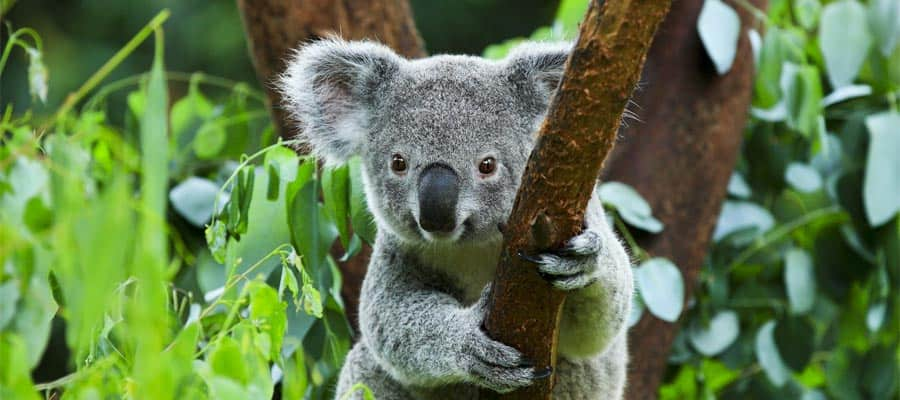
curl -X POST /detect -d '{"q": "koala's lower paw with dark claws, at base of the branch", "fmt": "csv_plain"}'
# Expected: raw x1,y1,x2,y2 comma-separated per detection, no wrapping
462,329,550,393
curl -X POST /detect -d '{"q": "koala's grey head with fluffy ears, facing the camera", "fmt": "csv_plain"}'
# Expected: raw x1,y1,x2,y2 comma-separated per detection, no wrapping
280,39,570,243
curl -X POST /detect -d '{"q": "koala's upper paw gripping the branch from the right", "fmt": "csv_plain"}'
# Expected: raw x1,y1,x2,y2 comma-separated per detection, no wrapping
519,230,603,290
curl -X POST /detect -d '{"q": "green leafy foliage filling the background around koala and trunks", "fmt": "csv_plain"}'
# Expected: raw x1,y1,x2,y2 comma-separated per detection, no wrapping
0,0,900,399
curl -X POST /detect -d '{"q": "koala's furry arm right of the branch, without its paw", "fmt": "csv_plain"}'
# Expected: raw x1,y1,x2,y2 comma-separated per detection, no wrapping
559,190,634,359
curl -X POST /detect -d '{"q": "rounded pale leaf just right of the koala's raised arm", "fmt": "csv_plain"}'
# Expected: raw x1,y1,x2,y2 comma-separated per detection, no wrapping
634,258,684,322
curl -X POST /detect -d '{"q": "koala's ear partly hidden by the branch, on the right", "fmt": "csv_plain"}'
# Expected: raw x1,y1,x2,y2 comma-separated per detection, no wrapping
506,42,572,105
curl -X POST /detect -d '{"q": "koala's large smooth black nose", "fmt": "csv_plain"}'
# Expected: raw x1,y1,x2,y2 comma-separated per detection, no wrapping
419,164,459,233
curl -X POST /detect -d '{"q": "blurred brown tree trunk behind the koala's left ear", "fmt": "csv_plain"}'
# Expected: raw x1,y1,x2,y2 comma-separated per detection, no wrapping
237,0,425,327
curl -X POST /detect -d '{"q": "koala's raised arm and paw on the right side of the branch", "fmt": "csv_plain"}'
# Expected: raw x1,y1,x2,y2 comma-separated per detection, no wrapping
526,199,634,359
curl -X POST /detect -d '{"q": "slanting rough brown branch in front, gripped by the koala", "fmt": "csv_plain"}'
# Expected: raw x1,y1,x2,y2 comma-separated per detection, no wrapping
480,0,671,400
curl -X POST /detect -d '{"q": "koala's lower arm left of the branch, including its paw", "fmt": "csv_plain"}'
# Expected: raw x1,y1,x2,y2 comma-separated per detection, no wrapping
360,245,534,392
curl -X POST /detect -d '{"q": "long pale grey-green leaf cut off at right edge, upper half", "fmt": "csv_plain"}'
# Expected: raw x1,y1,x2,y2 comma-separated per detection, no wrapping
863,112,900,226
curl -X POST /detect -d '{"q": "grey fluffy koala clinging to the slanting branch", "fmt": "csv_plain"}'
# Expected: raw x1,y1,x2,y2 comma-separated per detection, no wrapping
278,38,633,400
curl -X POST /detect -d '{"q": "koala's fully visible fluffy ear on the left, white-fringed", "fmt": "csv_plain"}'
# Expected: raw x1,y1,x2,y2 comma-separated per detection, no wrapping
278,38,404,163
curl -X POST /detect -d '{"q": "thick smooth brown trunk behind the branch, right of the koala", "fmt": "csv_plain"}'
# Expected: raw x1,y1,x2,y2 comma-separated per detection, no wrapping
604,0,766,400
